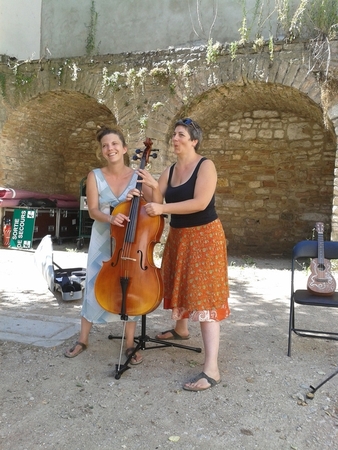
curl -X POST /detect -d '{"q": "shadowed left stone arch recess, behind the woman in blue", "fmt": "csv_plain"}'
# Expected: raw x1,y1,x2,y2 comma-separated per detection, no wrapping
0,90,116,195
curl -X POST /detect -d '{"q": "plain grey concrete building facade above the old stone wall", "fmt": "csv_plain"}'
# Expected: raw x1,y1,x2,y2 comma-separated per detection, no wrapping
0,0,277,60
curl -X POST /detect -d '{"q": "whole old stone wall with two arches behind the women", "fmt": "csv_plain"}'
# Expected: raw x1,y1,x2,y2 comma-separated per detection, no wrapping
0,43,338,254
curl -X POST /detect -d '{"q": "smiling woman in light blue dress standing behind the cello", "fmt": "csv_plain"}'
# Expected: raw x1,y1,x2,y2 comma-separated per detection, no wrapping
65,127,149,364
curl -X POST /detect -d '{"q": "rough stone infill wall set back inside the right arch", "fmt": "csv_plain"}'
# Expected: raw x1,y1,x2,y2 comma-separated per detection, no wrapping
205,110,335,254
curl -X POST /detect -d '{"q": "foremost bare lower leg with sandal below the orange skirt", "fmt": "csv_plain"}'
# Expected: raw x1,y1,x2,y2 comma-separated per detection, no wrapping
185,322,220,389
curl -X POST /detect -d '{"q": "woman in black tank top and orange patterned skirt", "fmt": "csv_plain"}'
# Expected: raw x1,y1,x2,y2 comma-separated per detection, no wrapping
135,118,230,391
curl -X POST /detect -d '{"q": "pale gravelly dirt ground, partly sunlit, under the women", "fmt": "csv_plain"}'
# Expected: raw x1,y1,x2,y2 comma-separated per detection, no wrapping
0,244,338,450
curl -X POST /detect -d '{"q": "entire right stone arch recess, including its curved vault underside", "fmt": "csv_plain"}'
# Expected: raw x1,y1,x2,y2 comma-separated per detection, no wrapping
168,83,336,254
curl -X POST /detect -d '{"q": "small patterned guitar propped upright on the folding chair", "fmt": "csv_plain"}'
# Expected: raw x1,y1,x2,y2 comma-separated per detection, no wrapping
307,222,336,295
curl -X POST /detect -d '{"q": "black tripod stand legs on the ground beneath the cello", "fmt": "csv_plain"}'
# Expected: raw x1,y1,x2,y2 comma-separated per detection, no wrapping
108,315,202,380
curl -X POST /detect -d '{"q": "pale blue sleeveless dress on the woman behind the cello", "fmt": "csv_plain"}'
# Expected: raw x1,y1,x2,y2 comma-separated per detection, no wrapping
81,169,139,324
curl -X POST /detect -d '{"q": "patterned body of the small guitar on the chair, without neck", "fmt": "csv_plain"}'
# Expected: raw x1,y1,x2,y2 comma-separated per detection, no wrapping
307,258,336,295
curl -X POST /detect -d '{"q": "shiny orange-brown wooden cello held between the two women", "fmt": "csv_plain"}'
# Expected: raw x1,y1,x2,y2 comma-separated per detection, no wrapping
95,138,164,320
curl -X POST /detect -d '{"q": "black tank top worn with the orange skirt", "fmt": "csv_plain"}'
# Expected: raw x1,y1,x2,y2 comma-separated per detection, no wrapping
165,158,218,228
